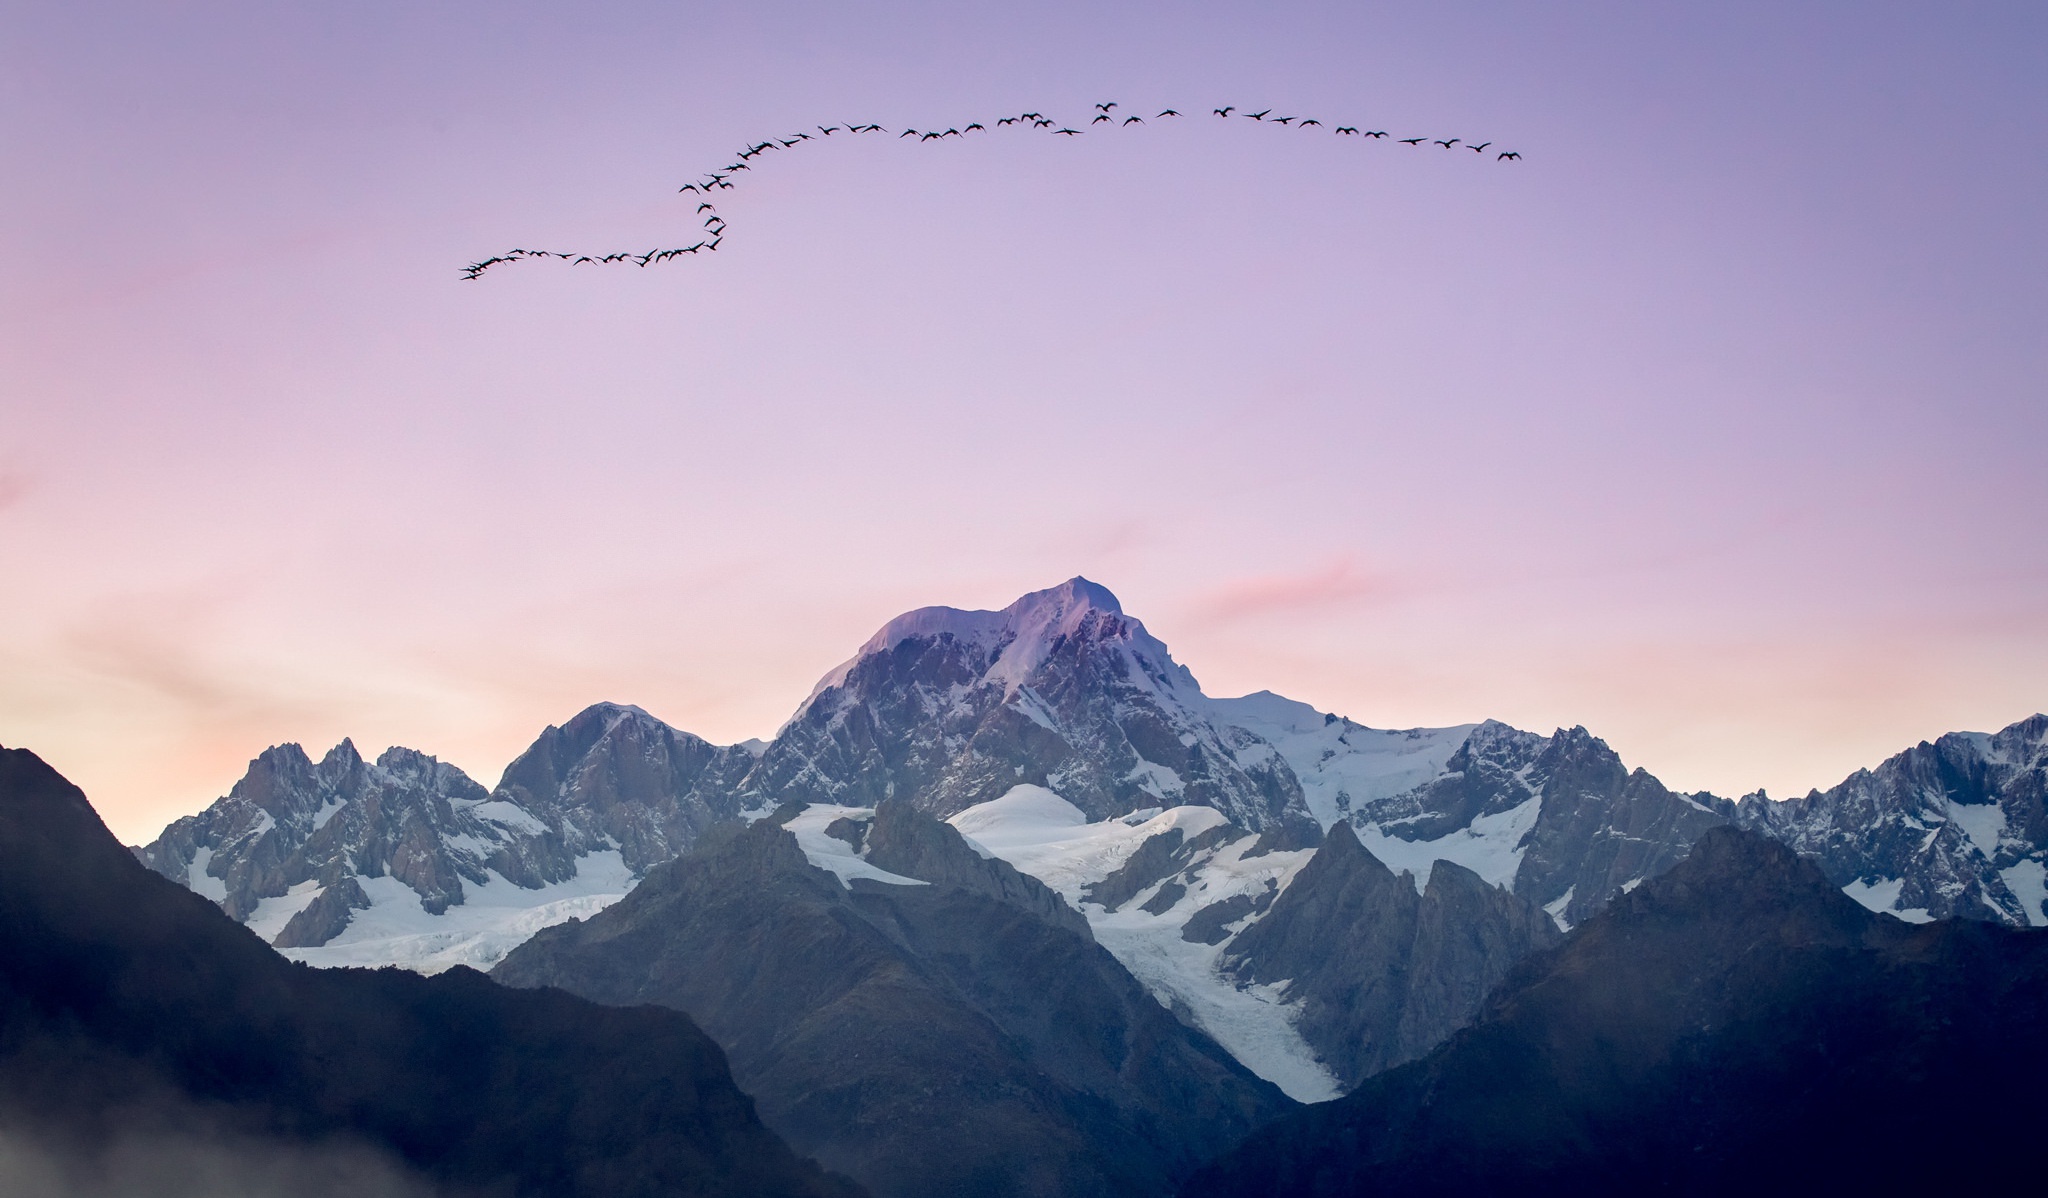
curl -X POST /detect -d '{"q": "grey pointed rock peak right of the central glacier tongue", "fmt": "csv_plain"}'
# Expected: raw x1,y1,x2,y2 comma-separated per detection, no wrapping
1190,823,1556,1087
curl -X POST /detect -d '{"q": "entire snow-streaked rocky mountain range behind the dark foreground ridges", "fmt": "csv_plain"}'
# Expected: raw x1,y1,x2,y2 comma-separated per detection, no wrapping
137,580,2048,1102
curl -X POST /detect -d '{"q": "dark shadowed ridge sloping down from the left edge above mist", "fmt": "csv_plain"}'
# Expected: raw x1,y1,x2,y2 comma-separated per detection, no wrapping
0,750,858,1198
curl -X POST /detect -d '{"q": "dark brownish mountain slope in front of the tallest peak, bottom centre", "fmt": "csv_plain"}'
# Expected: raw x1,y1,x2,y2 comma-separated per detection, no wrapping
494,803,1288,1198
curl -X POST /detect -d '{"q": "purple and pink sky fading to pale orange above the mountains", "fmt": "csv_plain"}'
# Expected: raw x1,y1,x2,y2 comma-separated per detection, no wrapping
0,0,2048,840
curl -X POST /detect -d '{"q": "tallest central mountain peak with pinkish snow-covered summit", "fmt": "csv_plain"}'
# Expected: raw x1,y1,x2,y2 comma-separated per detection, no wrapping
745,577,1315,842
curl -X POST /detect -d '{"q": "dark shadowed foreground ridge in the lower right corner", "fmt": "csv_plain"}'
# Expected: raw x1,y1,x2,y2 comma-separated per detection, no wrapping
1184,827,2048,1198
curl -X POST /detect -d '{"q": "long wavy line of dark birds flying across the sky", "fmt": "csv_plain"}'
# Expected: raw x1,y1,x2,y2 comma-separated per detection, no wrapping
463,100,1522,279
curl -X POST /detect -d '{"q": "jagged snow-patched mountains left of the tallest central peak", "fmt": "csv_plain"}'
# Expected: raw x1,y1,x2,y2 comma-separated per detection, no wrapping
137,702,754,971
